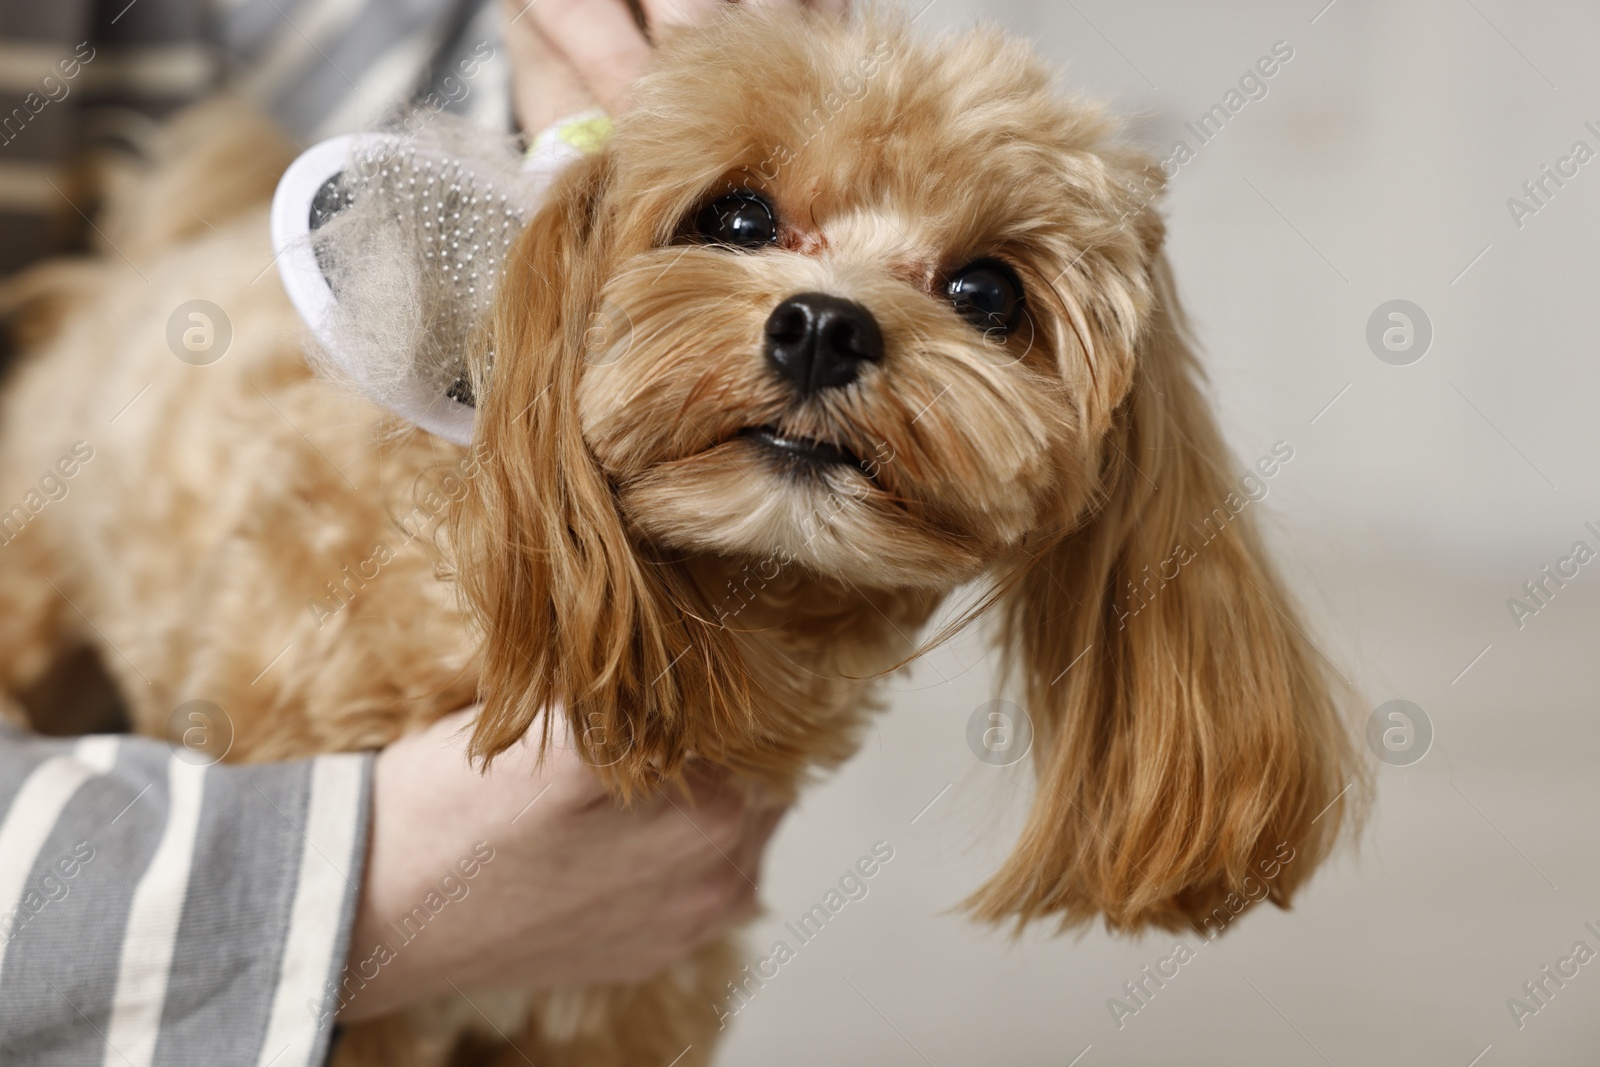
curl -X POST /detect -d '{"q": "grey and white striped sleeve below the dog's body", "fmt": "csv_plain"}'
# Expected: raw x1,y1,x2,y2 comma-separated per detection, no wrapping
0,725,371,1067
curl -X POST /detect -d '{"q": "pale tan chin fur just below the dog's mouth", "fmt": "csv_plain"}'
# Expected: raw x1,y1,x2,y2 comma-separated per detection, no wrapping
621,446,995,590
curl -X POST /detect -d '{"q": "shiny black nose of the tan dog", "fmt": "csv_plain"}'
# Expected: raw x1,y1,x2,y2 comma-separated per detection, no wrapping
766,293,883,397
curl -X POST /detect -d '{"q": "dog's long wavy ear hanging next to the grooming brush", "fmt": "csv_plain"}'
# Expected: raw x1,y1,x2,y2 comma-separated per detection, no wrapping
453,155,749,793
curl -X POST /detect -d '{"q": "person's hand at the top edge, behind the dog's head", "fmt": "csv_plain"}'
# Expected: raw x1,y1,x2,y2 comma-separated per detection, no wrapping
501,0,848,133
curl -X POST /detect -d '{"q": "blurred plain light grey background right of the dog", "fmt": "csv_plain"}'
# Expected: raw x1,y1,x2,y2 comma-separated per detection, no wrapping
722,0,1600,1067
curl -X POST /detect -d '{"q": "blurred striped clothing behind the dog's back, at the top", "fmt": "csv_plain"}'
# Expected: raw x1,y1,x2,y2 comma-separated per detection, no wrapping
0,0,510,275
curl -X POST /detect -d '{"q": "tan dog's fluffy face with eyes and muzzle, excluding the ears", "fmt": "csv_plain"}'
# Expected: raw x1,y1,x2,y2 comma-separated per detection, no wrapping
579,12,1152,587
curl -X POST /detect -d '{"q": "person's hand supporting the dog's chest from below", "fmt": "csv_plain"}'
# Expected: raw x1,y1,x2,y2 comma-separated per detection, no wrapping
339,710,782,1022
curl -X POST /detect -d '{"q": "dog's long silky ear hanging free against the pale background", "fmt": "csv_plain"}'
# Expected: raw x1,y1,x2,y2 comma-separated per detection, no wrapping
968,251,1362,931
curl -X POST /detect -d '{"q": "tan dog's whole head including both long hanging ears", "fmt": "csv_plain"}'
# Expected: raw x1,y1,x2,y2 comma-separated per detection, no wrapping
453,6,1355,929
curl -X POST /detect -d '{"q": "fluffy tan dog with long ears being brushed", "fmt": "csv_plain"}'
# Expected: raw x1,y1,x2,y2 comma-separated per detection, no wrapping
0,10,1357,1067
